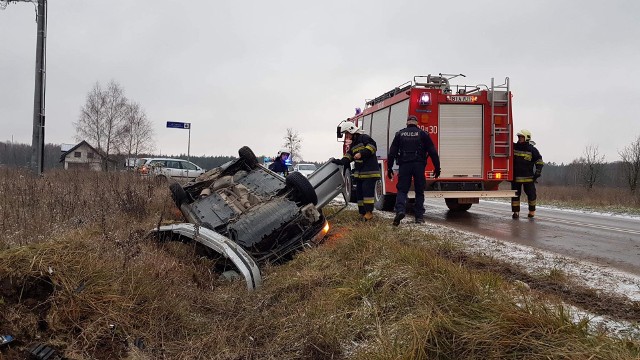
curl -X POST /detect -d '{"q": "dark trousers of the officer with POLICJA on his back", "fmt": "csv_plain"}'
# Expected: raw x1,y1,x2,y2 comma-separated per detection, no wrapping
395,162,427,219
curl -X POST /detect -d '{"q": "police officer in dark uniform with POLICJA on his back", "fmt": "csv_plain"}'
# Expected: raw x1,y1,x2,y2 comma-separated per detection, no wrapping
387,115,440,226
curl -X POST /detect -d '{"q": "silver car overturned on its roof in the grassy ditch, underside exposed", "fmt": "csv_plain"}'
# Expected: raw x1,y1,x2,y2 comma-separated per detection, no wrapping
152,146,346,289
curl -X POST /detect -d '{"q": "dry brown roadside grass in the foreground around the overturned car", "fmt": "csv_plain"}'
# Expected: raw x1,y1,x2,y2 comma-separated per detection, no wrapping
0,172,640,359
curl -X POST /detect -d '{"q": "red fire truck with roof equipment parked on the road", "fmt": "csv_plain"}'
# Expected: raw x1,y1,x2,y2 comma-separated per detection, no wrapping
338,74,515,211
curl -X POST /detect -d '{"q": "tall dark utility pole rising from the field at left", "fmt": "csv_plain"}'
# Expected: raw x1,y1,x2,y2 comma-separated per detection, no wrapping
0,0,47,175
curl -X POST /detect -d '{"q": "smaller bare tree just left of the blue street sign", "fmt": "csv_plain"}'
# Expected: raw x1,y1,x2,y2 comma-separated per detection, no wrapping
122,102,154,162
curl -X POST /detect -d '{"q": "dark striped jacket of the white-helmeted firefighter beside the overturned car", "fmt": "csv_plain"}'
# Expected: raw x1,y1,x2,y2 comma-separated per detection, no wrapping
342,134,381,179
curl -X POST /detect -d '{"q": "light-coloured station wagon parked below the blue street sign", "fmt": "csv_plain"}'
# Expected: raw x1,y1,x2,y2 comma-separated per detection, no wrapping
136,158,205,180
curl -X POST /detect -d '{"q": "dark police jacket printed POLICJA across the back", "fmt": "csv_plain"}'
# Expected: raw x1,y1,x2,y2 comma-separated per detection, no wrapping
387,125,440,169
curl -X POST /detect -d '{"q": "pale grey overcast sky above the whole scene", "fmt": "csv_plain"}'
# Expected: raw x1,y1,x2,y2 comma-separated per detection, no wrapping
0,0,640,163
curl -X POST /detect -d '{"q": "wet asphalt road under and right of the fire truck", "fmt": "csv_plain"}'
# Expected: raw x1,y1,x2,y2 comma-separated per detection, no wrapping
425,199,640,275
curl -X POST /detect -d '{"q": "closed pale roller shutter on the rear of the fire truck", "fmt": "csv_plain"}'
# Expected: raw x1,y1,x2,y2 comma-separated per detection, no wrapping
438,104,483,178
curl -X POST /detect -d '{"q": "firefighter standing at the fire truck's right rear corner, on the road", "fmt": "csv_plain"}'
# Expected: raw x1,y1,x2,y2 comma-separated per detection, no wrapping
511,129,544,219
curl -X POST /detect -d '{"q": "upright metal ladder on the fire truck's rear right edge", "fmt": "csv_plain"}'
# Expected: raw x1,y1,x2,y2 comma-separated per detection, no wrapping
489,77,512,171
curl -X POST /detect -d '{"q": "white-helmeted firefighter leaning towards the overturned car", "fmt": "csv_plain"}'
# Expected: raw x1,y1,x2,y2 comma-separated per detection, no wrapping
331,121,381,221
